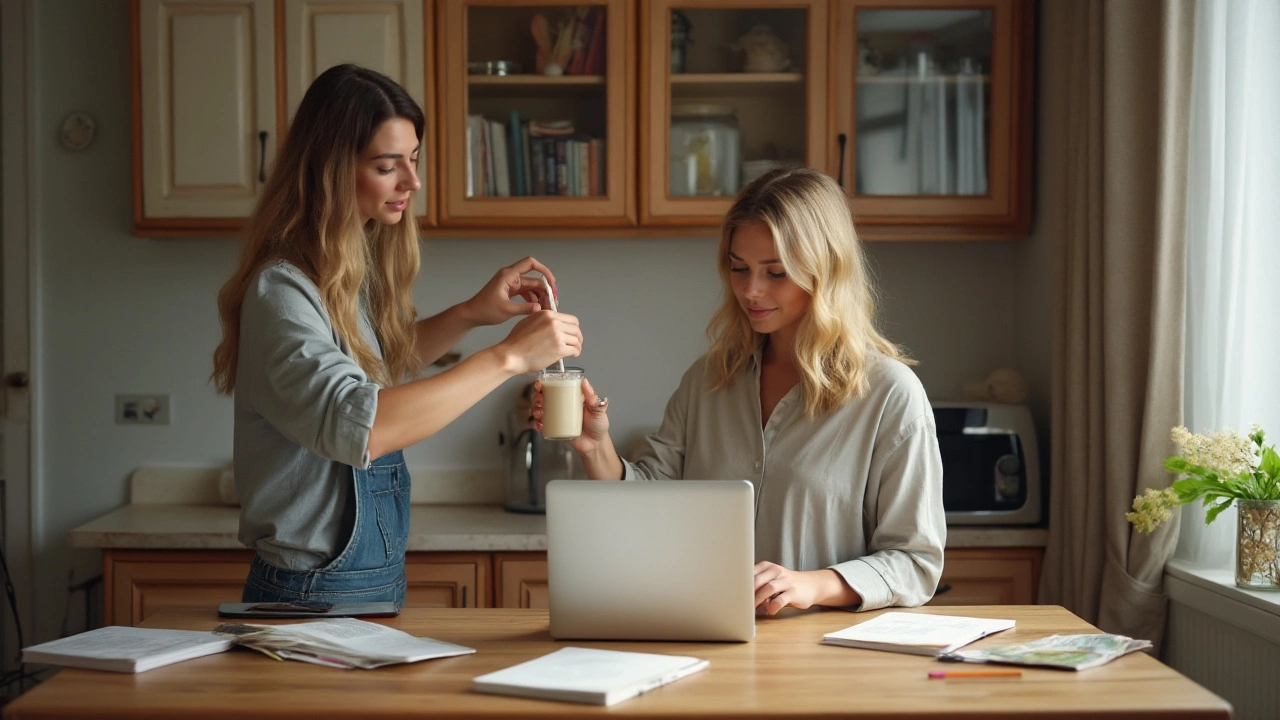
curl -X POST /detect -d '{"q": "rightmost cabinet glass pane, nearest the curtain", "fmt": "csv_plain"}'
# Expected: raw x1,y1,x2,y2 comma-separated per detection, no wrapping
854,10,992,196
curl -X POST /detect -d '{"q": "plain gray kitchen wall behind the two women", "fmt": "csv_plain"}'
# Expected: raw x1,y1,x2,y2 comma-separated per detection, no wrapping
24,0,1048,639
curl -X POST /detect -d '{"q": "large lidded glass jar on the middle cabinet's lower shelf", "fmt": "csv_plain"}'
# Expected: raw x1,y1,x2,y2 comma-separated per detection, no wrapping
669,102,742,197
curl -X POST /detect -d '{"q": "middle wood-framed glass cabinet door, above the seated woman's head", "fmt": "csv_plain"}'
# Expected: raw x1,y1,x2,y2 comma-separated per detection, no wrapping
639,0,829,227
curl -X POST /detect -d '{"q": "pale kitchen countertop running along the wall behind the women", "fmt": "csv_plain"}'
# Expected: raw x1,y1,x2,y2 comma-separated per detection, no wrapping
68,503,1048,552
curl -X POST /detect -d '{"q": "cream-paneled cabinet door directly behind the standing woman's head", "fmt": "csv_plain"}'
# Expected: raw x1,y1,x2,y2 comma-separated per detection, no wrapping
278,0,436,224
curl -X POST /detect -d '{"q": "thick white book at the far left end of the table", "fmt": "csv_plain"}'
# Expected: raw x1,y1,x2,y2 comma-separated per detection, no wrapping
22,625,232,673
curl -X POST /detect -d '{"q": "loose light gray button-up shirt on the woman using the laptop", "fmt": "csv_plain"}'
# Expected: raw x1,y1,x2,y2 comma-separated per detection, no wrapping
623,352,946,610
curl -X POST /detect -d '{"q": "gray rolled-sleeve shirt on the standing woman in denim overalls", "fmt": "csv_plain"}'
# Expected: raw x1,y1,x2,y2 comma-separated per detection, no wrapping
234,261,378,570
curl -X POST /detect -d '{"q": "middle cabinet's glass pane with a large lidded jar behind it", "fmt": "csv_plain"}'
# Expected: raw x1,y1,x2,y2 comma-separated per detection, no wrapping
667,8,808,197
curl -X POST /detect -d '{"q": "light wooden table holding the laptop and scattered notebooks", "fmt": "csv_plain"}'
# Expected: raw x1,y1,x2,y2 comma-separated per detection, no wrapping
5,606,1231,720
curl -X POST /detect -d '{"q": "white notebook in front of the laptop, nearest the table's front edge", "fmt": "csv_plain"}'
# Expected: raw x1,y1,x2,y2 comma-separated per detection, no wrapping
471,647,708,705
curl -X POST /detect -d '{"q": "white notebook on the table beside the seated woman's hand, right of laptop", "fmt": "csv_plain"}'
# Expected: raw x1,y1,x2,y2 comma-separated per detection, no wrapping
822,612,1014,656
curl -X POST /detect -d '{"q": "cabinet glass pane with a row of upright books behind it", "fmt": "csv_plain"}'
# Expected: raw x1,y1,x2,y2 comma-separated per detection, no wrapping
466,5,608,197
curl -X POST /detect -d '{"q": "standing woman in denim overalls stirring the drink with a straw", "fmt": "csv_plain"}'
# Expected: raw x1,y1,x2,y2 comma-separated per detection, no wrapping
212,65,582,603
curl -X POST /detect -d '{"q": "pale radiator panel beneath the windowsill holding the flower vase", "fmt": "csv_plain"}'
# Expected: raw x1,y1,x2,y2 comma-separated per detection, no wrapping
1161,566,1280,720
